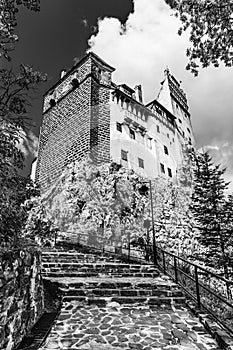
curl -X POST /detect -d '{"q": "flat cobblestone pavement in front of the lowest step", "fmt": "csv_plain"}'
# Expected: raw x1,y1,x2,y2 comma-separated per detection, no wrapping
41,300,219,350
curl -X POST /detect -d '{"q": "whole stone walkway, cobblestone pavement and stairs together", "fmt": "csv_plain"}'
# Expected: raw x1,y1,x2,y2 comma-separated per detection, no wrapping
41,251,222,350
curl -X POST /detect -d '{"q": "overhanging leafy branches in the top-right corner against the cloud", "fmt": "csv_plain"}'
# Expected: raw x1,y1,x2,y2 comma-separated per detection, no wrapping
165,0,233,76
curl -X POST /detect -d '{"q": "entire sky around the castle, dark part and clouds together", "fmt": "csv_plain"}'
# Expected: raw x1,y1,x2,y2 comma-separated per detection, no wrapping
12,0,233,191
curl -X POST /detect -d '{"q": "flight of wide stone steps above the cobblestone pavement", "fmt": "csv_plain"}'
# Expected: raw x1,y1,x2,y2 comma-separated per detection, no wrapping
42,251,185,305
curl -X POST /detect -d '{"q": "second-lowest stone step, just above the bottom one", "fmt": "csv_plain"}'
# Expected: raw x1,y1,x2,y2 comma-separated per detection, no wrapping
60,288,183,297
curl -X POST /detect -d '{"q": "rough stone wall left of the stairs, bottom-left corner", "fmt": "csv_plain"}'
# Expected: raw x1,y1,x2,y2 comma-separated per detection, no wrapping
0,247,44,350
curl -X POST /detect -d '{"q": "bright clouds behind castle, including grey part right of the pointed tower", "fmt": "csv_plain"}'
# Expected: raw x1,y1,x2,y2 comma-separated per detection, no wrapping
89,0,233,191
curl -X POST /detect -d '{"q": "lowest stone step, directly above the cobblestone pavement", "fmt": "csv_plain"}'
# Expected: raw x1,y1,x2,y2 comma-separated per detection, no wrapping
62,295,186,306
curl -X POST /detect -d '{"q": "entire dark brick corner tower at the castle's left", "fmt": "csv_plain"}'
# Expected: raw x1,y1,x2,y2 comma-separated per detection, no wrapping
36,53,114,190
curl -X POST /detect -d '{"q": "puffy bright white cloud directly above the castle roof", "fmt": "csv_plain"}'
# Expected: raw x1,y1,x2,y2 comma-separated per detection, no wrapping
89,0,188,101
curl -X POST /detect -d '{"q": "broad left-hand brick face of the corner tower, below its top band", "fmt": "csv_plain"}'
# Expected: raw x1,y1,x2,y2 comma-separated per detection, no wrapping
37,78,91,189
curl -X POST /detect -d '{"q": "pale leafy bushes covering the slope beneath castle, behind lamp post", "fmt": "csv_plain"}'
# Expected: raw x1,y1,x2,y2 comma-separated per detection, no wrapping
25,154,197,264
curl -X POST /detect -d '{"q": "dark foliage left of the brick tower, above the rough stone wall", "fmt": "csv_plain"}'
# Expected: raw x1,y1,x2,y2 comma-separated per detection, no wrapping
0,65,45,242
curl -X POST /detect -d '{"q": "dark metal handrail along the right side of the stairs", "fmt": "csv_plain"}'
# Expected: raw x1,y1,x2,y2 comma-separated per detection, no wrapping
53,231,233,335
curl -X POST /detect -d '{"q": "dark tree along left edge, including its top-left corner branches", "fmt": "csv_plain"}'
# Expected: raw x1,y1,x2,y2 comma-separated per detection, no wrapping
0,0,46,245
